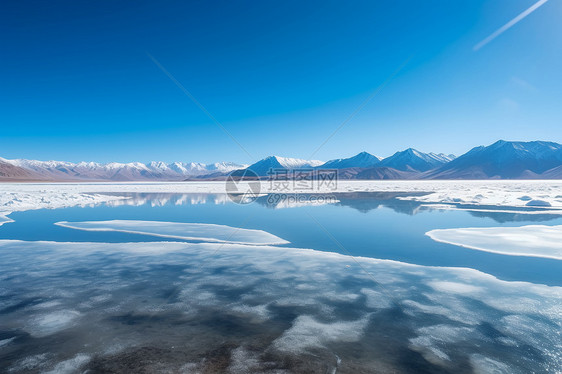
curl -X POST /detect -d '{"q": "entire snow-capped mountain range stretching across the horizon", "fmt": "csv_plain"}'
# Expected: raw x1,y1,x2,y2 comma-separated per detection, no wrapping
0,140,562,181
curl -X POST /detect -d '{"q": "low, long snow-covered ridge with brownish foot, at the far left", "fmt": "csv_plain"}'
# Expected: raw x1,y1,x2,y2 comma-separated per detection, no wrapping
1,159,247,181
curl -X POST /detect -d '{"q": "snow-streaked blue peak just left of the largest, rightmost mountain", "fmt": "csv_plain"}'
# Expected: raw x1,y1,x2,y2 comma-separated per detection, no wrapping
380,148,455,172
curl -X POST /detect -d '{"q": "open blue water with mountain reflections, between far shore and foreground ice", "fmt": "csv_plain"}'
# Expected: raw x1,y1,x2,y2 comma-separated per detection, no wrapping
0,192,562,286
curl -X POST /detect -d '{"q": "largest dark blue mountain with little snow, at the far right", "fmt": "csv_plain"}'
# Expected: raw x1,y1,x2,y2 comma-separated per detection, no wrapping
426,140,562,179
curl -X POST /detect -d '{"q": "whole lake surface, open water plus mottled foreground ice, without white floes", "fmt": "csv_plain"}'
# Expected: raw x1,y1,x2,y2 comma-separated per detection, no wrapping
0,193,562,373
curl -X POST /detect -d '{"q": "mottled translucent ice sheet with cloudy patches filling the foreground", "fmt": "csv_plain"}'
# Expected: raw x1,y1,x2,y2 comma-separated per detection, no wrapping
0,240,562,373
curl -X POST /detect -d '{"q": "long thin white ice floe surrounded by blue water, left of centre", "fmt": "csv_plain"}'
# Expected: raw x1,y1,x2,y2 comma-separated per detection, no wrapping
55,220,289,245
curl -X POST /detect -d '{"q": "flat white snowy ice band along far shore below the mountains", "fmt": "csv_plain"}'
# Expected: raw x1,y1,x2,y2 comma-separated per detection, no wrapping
0,180,562,213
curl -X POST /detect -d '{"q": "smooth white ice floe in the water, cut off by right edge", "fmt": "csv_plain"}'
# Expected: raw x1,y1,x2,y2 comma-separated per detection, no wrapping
426,225,562,260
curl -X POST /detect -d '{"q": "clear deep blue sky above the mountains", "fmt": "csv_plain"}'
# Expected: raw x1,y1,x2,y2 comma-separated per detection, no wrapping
0,0,562,163
